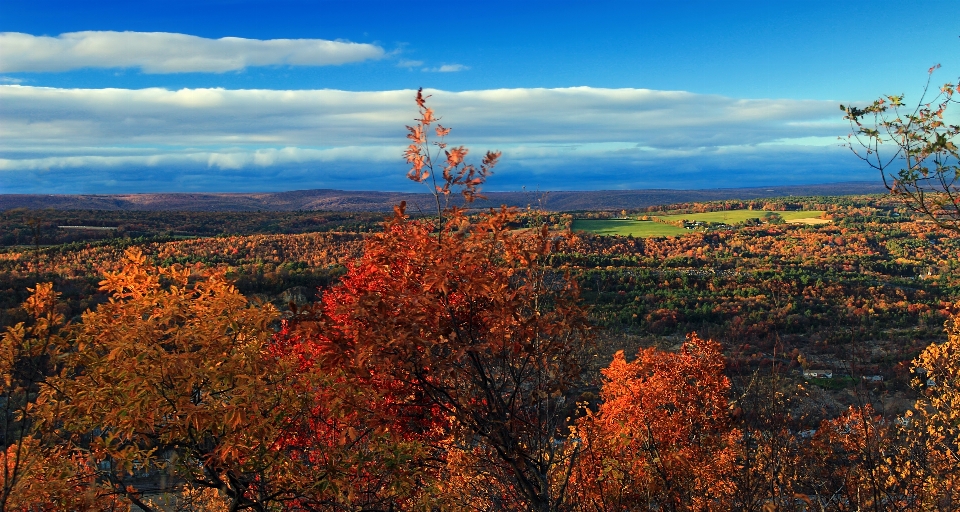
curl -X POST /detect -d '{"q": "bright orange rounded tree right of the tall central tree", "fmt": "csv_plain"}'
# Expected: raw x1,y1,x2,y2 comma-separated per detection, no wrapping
574,334,737,511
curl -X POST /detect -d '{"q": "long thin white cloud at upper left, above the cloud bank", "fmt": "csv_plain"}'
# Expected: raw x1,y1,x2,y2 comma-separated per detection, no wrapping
0,31,385,73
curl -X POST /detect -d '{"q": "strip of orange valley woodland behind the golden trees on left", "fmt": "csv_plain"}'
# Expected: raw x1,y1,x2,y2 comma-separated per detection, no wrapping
0,233,363,324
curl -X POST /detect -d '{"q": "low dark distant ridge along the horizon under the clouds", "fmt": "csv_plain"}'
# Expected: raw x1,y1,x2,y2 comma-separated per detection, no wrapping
0,181,886,213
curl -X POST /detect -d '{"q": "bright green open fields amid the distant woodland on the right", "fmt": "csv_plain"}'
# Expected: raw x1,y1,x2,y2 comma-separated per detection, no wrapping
573,210,823,238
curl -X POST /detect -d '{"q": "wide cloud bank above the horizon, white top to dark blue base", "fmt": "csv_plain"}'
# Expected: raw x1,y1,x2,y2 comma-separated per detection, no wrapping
0,85,874,193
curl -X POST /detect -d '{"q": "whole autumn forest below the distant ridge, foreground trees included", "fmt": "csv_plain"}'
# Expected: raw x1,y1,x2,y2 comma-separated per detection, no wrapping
0,84,960,512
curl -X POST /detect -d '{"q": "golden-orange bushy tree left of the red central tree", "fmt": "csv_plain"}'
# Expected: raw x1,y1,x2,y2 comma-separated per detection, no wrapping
28,249,314,510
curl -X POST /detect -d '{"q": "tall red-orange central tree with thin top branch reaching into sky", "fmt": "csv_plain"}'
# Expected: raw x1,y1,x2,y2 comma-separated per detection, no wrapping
282,92,588,510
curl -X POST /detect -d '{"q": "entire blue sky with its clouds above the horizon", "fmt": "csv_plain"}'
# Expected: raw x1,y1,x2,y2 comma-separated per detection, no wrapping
0,0,960,193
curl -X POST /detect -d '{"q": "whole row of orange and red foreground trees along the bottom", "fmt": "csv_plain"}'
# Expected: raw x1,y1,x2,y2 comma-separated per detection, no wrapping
0,233,960,511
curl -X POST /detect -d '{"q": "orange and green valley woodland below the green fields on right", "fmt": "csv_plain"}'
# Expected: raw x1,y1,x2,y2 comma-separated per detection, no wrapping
568,218,960,340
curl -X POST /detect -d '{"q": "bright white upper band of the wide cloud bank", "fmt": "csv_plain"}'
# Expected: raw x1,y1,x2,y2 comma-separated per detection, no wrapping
0,85,848,151
